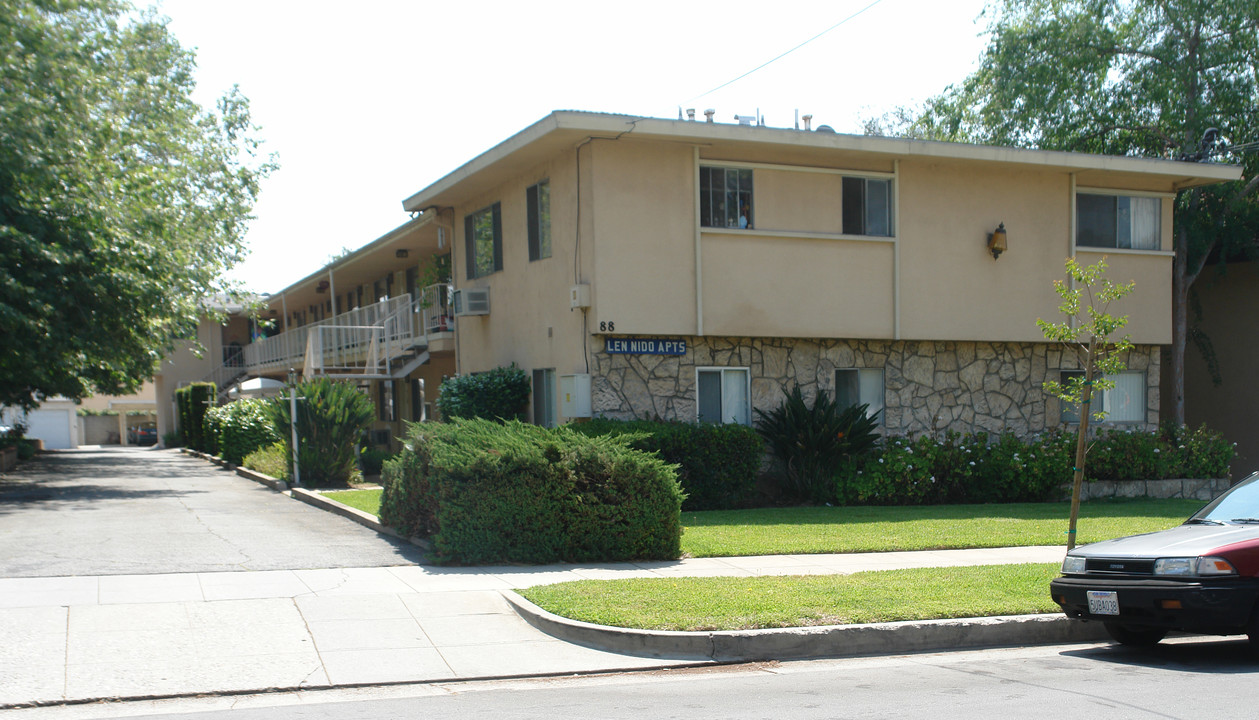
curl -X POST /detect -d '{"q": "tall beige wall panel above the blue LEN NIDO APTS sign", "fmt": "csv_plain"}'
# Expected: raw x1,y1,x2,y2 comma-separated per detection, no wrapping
589,141,695,335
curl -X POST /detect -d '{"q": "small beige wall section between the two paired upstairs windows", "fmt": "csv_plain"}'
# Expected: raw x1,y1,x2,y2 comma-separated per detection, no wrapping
752,170,844,234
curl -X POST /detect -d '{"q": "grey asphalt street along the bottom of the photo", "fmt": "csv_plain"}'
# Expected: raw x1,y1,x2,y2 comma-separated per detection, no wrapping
6,638,1259,720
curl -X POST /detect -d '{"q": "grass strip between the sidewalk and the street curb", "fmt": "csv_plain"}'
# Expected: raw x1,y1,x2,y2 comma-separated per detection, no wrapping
517,563,1058,631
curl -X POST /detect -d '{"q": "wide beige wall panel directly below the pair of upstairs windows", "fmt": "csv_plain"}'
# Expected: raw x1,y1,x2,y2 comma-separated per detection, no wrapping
704,234,893,339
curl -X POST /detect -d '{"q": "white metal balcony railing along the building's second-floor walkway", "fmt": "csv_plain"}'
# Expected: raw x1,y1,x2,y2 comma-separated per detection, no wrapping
244,284,454,375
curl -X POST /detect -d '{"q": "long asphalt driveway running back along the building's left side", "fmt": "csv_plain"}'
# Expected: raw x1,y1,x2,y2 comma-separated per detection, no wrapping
0,447,422,578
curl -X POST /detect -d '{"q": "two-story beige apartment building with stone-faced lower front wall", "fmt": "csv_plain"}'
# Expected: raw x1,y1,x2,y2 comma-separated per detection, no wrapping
154,111,1240,450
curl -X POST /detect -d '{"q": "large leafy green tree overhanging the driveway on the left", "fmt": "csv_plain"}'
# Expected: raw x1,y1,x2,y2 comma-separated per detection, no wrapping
0,0,273,407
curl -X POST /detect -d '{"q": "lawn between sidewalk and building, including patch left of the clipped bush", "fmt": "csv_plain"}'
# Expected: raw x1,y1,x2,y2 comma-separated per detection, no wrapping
317,490,1202,558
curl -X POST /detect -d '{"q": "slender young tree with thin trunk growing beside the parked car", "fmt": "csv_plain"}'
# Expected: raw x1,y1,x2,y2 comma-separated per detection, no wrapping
1036,258,1136,550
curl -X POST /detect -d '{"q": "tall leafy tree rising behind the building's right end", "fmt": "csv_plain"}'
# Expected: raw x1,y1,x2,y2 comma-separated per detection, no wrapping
867,0,1259,423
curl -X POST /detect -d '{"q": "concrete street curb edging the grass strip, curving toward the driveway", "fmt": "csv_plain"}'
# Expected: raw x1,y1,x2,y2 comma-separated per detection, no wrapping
501,590,1107,662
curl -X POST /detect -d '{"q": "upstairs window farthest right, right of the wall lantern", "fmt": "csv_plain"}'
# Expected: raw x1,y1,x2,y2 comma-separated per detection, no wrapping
1075,193,1162,250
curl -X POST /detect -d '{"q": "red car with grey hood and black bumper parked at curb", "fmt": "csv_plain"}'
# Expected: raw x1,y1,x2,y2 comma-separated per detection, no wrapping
1050,473,1259,652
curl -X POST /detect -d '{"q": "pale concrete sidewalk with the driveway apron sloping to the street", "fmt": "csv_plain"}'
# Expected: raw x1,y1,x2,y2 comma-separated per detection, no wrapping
0,546,1079,709
